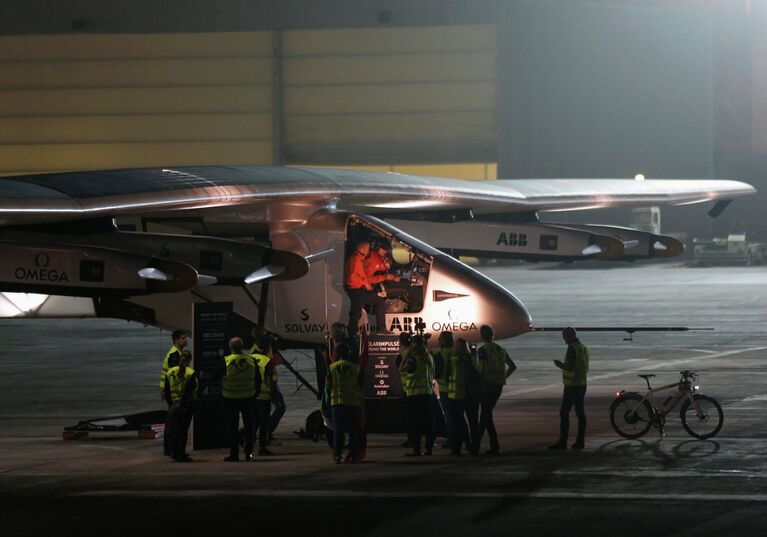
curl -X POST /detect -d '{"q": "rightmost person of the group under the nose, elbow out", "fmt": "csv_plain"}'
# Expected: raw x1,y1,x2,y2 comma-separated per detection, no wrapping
477,324,517,455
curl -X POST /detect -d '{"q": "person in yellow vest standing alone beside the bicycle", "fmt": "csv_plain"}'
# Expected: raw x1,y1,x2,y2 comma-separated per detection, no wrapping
549,327,589,449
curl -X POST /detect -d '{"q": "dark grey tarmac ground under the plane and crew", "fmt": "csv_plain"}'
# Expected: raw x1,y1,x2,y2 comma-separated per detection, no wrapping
0,263,767,536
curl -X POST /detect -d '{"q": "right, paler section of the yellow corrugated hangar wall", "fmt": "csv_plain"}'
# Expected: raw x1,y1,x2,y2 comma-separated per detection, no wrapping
283,26,496,163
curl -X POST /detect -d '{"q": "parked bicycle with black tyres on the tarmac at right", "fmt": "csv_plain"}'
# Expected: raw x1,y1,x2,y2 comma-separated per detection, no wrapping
610,370,724,440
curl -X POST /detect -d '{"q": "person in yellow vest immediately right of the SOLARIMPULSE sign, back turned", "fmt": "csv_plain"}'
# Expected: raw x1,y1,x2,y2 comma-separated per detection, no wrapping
405,335,434,456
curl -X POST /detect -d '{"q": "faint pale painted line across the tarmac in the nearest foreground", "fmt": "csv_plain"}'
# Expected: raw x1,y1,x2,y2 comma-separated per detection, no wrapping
70,489,767,503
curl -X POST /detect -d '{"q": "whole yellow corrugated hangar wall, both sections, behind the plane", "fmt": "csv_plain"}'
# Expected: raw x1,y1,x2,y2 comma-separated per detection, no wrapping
0,26,496,174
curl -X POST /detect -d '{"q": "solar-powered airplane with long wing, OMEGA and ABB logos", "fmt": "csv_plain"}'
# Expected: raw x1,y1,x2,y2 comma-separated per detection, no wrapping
0,167,755,347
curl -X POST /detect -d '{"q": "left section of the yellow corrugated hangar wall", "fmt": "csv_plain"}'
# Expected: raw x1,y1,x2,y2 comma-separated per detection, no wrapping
0,32,272,173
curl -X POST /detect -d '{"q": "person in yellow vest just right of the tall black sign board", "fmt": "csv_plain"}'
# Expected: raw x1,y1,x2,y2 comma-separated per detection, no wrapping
221,337,262,462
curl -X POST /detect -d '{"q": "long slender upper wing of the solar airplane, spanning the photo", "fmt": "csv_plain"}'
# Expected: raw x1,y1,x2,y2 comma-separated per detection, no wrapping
0,166,755,226
